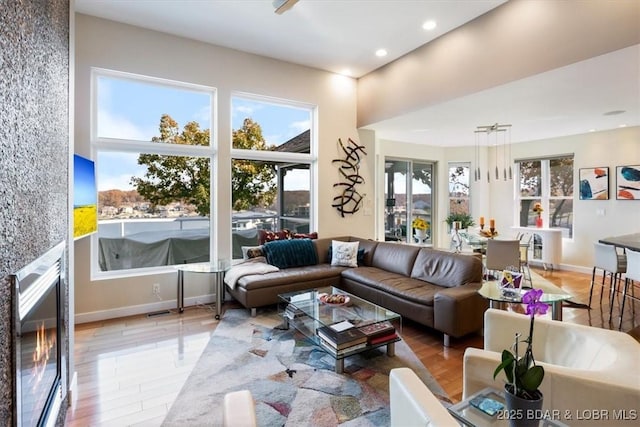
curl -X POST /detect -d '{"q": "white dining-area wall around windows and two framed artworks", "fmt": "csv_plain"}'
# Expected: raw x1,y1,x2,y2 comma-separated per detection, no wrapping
376,127,640,272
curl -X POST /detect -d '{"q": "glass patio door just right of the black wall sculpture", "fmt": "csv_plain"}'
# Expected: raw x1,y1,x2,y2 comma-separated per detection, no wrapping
385,158,434,244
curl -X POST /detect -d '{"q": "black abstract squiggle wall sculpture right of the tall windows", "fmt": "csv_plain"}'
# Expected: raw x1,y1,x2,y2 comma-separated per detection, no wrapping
331,138,367,218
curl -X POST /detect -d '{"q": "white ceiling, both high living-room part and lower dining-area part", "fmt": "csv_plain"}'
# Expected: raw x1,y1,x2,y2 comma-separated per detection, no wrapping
75,0,640,146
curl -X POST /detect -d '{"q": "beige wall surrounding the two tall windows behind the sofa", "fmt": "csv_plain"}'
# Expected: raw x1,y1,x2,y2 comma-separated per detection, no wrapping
75,14,374,321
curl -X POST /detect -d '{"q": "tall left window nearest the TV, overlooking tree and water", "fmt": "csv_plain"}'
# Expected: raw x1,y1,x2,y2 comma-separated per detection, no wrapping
91,69,215,276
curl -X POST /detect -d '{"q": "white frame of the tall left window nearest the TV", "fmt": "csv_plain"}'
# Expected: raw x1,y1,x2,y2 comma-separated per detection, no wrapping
89,67,219,281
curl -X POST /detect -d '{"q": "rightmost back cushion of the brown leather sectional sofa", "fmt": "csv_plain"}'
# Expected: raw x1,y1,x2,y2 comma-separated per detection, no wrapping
411,248,482,288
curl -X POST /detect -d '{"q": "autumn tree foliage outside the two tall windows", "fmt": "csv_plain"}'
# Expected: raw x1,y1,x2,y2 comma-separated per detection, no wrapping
131,114,276,216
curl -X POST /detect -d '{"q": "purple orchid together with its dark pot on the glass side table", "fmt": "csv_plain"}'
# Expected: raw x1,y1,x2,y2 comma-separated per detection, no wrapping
493,289,549,426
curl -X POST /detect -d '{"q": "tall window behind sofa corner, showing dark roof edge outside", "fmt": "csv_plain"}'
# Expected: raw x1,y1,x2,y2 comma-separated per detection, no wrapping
231,95,316,258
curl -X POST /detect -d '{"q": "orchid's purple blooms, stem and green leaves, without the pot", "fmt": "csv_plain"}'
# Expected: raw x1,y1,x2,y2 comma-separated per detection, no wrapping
493,289,549,400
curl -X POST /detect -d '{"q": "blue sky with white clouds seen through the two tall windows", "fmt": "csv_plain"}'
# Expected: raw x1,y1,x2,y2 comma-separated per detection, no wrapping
96,76,311,191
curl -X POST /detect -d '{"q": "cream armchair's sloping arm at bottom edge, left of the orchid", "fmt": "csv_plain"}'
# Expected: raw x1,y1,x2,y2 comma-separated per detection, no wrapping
389,368,458,427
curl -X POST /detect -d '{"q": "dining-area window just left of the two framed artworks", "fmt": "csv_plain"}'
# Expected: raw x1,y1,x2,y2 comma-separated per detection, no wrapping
517,156,573,237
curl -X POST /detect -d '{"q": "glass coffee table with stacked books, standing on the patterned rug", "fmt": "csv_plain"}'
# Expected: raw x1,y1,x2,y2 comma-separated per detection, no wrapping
278,286,402,374
